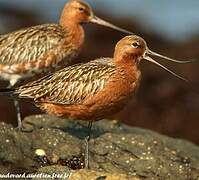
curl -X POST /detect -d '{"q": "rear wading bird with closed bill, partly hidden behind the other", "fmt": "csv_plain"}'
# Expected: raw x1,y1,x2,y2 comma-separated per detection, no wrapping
0,0,132,129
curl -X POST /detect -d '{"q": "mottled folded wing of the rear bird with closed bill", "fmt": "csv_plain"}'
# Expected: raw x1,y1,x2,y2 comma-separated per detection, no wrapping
0,24,68,65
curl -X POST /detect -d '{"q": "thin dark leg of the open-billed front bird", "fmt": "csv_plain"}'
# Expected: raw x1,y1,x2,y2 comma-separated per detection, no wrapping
84,121,93,169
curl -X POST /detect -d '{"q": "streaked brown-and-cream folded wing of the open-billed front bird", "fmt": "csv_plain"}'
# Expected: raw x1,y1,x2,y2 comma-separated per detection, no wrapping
16,58,115,104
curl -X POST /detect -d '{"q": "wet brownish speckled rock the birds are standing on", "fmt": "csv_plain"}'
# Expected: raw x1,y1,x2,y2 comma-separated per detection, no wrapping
0,115,199,180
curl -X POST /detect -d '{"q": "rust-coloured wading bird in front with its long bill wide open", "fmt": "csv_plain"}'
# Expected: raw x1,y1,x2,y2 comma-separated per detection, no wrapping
1,35,194,167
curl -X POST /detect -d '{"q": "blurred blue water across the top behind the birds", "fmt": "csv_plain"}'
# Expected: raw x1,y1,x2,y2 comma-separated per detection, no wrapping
0,0,199,42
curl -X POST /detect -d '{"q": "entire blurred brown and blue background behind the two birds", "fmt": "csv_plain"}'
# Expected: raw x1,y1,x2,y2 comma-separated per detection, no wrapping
0,0,199,143
